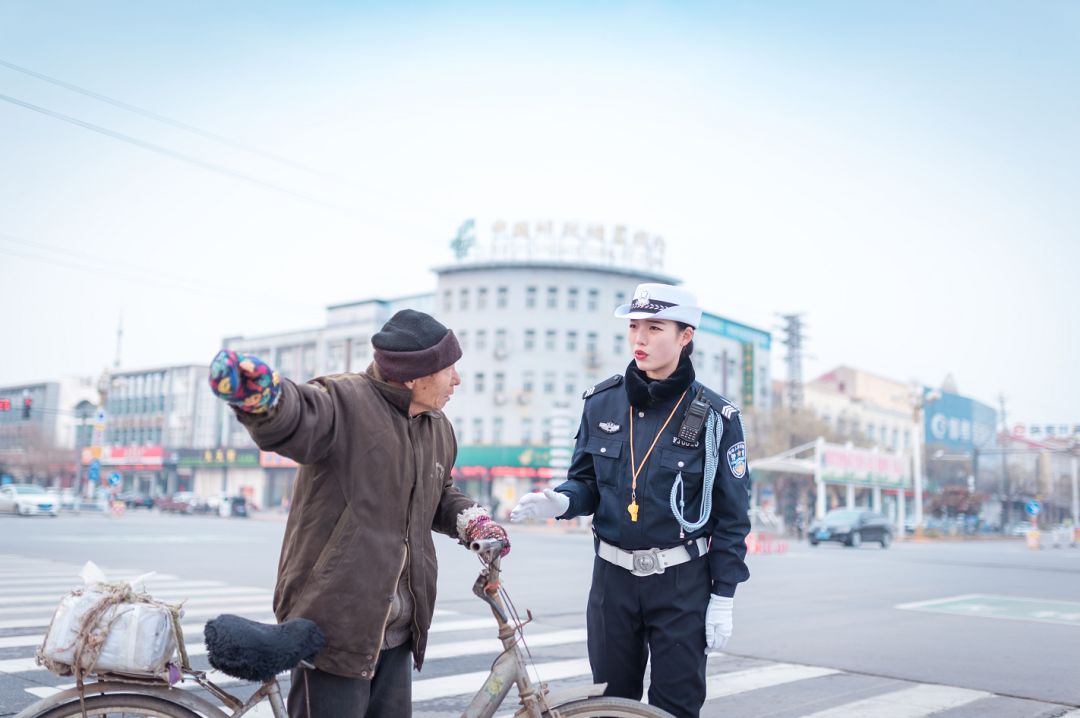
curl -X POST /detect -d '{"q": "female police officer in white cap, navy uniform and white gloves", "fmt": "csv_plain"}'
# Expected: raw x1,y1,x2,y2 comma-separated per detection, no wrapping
511,284,750,716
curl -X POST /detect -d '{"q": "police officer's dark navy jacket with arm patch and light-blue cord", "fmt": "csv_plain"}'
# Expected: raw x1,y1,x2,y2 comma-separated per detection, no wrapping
555,369,750,596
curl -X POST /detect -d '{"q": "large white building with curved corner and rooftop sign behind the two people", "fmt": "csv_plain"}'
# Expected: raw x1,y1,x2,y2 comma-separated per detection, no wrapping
220,221,771,510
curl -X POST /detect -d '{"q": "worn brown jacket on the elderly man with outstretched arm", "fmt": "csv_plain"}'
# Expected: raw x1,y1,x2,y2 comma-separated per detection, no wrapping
237,364,475,678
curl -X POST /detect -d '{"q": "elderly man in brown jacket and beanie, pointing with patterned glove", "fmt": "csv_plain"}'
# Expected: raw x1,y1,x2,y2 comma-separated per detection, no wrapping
210,309,510,718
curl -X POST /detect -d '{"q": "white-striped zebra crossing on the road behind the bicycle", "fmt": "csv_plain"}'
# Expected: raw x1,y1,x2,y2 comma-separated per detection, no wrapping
0,555,1080,718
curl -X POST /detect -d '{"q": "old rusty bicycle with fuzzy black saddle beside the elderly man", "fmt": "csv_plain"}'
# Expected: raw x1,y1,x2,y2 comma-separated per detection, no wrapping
15,540,672,718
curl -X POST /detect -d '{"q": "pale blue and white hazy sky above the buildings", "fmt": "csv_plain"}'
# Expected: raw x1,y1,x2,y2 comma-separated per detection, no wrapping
0,0,1080,423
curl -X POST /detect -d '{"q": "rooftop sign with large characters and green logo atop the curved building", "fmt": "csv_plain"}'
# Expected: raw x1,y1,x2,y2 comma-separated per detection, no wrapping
450,219,665,271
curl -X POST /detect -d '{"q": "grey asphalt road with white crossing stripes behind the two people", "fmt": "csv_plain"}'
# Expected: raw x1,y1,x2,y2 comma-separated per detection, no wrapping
0,512,1080,718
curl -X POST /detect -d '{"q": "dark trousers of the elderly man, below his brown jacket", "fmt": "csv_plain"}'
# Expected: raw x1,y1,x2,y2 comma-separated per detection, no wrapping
287,641,413,718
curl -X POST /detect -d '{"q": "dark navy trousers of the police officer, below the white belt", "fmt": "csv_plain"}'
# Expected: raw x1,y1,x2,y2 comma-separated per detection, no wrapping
586,556,711,718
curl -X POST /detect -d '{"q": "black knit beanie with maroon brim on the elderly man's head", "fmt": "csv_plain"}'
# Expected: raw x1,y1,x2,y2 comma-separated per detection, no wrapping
372,309,461,383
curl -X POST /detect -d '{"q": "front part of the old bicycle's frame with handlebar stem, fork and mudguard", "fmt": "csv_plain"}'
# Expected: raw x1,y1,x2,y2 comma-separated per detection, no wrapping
461,544,605,718
